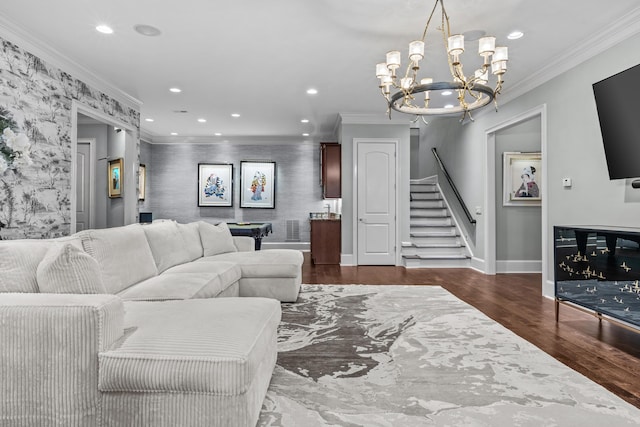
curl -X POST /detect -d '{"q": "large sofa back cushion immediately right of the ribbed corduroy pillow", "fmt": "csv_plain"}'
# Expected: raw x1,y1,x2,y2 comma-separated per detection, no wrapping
77,224,158,294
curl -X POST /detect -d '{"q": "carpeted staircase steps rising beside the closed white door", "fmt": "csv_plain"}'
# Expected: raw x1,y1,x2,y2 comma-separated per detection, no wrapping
402,178,470,268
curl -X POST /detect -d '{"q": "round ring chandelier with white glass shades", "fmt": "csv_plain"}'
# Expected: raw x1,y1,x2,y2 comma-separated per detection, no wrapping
376,0,509,123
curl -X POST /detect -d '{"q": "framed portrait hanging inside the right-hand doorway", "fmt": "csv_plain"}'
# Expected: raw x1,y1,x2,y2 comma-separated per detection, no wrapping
502,152,543,206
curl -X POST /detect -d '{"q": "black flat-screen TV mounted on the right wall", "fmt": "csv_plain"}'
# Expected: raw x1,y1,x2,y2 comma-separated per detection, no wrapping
593,65,640,181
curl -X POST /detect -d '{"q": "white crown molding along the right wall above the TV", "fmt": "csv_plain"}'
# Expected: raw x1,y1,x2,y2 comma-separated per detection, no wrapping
500,7,640,105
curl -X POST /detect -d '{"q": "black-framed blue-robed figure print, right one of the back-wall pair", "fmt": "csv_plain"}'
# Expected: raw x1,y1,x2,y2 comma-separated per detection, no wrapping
240,160,276,209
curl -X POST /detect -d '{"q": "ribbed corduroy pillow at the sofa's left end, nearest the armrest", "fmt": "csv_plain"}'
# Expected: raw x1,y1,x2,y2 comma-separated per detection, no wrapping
36,243,107,294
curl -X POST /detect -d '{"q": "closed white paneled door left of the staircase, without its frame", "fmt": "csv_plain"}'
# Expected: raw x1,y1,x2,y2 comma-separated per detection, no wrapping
357,142,396,265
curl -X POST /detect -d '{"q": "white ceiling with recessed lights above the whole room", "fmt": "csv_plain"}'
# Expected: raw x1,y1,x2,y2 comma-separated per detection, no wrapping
0,0,640,141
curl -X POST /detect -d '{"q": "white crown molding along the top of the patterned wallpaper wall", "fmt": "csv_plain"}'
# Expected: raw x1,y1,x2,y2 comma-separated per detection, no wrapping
0,15,142,111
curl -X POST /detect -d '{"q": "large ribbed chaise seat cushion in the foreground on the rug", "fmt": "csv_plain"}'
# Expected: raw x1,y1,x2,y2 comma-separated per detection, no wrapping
99,298,281,396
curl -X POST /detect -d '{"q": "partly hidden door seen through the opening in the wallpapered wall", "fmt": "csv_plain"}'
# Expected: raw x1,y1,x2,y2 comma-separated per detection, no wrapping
76,139,95,232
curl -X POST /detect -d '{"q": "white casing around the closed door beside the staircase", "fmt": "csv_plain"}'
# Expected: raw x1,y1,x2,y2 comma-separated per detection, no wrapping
351,138,402,265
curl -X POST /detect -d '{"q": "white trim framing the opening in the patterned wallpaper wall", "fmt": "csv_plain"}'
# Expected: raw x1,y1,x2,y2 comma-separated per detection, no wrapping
70,99,139,234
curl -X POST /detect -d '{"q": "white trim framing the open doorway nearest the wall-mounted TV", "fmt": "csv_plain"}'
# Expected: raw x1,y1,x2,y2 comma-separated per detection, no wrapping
484,104,549,293
